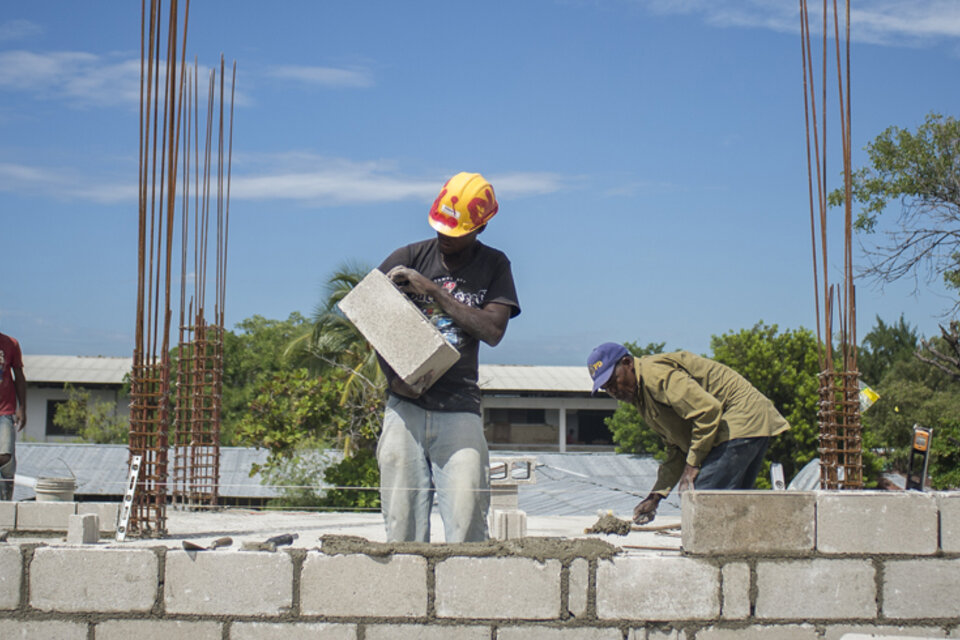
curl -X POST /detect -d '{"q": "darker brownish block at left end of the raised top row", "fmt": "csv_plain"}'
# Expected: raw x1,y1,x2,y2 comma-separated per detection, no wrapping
680,491,816,555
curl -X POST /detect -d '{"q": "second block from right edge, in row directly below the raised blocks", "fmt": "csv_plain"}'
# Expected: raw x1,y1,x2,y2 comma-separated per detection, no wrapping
754,559,877,620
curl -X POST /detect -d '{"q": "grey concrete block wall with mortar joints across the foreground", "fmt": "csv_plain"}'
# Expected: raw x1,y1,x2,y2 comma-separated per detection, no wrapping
0,492,960,640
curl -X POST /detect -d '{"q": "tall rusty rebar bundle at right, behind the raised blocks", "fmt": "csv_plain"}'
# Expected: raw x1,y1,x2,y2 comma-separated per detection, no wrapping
800,0,863,489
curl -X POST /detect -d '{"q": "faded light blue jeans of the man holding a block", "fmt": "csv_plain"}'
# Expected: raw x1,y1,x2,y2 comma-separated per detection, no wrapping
377,396,490,542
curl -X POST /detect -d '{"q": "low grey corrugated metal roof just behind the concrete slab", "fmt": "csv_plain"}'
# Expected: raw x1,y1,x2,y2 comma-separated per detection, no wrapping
7,442,680,517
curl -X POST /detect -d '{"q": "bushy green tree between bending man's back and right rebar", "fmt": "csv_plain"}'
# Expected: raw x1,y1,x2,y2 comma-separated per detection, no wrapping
710,321,820,487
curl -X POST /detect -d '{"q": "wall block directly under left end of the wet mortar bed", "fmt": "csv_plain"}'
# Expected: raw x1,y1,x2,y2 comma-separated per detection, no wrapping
300,552,427,617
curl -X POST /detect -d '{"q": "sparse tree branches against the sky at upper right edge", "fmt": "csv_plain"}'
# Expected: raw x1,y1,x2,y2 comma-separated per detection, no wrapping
829,113,960,298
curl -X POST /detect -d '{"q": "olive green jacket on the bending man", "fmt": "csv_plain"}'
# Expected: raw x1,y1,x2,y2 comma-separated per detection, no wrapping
633,351,790,496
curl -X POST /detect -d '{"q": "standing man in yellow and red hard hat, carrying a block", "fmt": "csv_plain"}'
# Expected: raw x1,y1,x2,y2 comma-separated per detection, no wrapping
377,173,520,542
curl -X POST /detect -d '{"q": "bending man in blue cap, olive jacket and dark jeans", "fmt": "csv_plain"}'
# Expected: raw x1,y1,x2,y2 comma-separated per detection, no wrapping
587,342,790,524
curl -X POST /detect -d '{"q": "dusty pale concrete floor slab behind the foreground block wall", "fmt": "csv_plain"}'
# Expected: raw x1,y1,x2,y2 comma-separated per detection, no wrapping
10,508,680,557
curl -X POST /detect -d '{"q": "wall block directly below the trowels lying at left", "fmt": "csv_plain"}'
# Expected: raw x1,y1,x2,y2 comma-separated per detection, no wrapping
164,551,293,616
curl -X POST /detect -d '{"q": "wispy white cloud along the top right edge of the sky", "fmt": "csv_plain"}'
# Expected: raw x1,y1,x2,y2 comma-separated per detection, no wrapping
637,0,960,46
